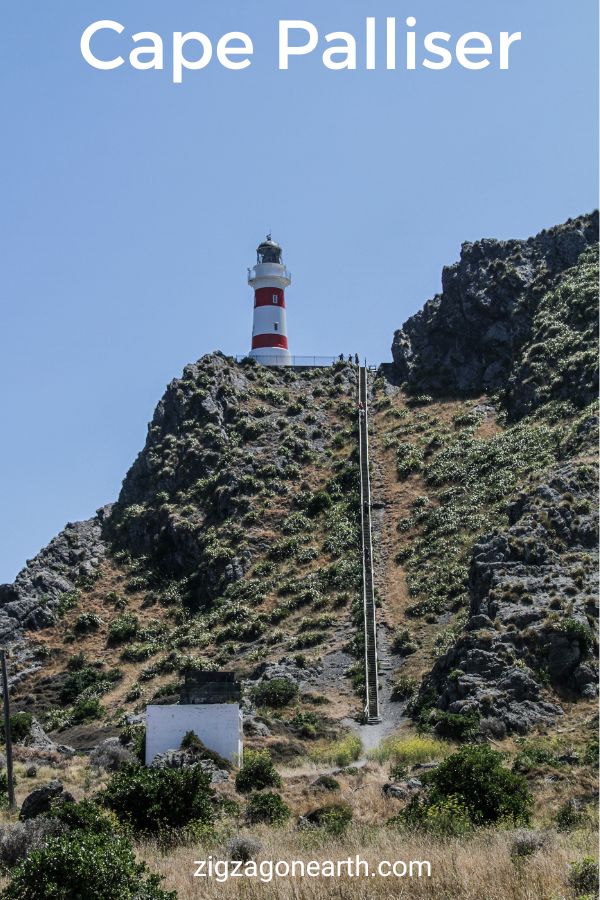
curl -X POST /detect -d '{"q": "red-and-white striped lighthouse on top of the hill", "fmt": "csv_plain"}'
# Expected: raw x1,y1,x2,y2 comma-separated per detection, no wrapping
248,234,292,366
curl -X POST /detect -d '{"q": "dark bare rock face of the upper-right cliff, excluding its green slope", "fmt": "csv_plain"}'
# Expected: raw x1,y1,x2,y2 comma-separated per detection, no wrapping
392,212,598,409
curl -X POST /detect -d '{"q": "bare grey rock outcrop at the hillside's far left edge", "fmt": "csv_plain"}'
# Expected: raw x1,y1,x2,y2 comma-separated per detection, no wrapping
0,507,110,644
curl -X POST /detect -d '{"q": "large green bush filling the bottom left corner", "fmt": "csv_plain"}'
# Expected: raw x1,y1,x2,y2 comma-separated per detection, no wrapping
3,832,176,900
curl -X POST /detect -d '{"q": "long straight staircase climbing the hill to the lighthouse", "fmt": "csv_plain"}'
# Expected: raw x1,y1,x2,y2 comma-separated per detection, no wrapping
358,366,381,725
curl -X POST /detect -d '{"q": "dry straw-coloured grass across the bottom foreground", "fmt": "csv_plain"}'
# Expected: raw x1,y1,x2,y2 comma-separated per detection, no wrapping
139,826,595,900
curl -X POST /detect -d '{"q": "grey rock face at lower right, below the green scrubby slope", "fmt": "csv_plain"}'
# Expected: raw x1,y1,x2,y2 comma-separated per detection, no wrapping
421,464,598,737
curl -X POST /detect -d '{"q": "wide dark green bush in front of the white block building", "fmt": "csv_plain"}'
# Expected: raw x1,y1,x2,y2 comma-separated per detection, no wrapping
101,766,214,833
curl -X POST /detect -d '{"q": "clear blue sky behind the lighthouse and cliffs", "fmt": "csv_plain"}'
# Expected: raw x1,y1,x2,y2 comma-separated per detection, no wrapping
0,0,598,581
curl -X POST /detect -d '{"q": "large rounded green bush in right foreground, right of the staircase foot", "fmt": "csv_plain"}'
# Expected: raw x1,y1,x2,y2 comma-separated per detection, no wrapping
427,745,532,825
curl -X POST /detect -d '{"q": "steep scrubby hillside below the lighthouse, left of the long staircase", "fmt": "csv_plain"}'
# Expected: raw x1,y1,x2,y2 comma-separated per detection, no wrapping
4,354,370,747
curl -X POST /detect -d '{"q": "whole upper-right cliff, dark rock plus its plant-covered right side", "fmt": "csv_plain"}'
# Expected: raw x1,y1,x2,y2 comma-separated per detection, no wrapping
392,212,598,415
